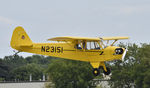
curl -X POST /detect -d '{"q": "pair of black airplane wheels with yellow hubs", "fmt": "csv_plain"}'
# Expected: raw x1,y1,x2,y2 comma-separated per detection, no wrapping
93,67,111,76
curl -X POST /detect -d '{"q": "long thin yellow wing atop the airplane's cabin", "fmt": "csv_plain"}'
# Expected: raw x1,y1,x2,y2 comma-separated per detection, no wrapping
48,36,129,41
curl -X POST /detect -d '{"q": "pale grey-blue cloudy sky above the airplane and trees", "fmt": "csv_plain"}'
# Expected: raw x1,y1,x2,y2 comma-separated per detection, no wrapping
0,0,150,58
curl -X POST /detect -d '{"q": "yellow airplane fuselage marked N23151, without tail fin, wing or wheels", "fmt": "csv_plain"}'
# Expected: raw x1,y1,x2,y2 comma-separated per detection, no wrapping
19,43,122,62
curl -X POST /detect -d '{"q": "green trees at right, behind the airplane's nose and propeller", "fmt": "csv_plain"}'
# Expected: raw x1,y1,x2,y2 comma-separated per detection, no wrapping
110,44,150,88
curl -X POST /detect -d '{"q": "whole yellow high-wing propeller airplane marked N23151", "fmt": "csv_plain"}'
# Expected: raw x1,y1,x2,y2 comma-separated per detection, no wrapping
11,26,129,76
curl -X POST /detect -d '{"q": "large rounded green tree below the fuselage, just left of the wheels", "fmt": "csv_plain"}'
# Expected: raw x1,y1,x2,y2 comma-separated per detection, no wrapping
47,59,93,88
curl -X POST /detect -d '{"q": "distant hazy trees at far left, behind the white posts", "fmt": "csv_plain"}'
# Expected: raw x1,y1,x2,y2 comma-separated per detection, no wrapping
0,55,54,81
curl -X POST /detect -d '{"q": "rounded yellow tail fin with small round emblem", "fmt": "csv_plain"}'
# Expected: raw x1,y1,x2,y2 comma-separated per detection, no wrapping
10,26,33,51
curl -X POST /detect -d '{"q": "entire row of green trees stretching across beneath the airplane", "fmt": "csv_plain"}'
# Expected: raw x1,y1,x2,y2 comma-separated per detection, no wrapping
0,43,150,88
